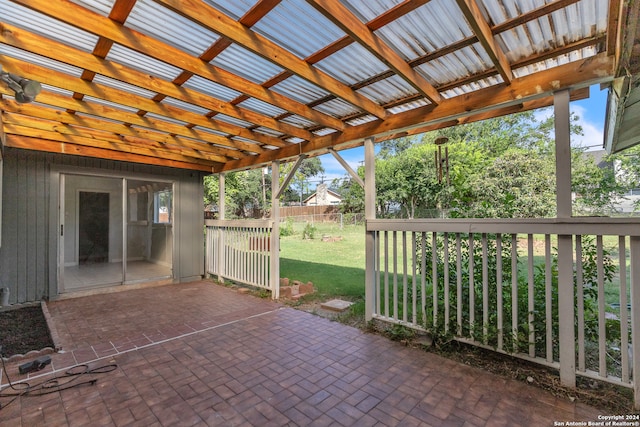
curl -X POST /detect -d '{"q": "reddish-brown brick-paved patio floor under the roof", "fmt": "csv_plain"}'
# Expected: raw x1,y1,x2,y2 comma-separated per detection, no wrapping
0,281,605,426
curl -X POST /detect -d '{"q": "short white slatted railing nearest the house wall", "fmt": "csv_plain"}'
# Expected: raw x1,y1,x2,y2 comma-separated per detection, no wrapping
205,220,277,290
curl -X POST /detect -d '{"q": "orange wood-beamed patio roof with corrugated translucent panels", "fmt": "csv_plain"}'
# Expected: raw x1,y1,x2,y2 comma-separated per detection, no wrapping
0,0,638,173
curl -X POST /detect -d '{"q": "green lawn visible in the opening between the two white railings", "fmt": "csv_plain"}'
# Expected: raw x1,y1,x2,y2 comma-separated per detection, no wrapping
280,223,365,299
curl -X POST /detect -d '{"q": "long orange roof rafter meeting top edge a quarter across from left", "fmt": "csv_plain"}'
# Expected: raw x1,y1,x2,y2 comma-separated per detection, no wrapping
156,0,387,118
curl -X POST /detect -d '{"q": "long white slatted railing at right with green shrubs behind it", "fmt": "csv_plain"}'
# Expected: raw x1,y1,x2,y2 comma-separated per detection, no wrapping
367,218,640,406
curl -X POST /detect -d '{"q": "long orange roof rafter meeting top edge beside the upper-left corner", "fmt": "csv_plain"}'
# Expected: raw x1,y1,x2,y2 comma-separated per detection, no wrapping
10,0,346,130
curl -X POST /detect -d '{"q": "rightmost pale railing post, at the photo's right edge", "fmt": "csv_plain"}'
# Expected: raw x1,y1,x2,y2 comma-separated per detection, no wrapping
620,236,640,409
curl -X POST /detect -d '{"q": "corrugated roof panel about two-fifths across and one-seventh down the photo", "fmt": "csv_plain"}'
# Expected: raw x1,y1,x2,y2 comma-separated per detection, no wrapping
211,44,283,83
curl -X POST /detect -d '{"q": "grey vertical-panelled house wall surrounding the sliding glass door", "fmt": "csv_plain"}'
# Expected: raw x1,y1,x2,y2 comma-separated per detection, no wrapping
0,148,204,304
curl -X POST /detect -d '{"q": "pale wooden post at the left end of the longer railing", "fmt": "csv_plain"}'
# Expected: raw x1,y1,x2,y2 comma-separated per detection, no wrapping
364,138,376,322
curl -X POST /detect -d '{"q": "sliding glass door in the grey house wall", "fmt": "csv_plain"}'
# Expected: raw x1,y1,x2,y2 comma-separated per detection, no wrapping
59,174,173,292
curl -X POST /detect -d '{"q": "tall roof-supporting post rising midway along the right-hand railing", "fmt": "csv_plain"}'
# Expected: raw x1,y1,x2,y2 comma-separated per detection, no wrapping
553,90,576,387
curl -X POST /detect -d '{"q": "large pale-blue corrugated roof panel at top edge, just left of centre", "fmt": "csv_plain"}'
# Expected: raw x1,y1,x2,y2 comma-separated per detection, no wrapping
252,0,345,58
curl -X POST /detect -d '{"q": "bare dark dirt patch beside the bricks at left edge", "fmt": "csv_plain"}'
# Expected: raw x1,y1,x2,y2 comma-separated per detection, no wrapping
0,305,54,358
